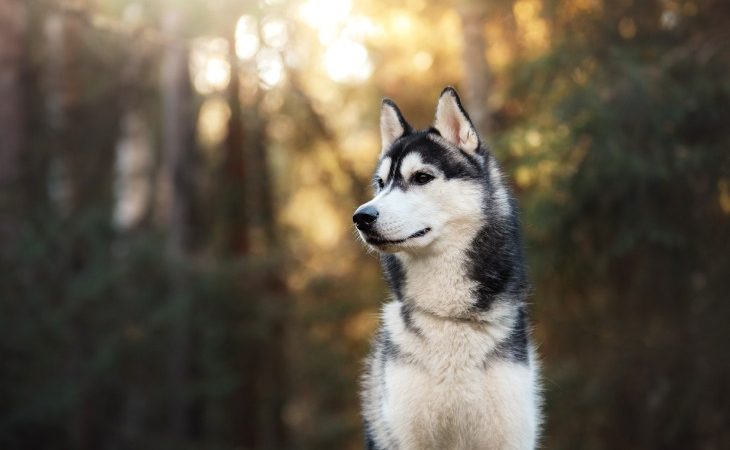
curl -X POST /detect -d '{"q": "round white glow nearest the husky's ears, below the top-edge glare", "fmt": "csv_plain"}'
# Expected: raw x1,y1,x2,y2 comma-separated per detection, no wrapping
324,39,373,83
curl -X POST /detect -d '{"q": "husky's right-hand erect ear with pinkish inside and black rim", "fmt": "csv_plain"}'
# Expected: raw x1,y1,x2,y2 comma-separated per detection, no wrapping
433,86,479,153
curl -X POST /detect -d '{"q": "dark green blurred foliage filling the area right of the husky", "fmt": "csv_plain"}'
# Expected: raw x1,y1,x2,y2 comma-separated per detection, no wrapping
502,2,730,448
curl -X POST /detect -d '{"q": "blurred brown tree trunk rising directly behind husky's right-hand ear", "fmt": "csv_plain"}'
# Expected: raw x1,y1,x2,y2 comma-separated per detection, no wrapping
459,1,492,138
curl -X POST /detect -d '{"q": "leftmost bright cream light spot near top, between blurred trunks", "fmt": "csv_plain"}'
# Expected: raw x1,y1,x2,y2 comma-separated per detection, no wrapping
190,38,231,94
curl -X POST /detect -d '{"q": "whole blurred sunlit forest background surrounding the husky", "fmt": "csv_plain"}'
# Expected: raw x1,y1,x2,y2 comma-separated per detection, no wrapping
0,0,730,450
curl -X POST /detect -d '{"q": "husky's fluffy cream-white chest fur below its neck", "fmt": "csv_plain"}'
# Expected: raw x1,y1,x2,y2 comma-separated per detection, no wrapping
366,302,539,450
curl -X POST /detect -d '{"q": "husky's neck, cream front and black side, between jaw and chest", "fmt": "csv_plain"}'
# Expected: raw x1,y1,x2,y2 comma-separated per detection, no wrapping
384,212,527,322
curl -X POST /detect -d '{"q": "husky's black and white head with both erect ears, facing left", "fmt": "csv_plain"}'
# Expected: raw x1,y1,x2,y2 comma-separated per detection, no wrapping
353,87,507,253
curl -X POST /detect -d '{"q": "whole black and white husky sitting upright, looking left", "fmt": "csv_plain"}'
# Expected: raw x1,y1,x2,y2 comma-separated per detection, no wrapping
353,87,541,450
